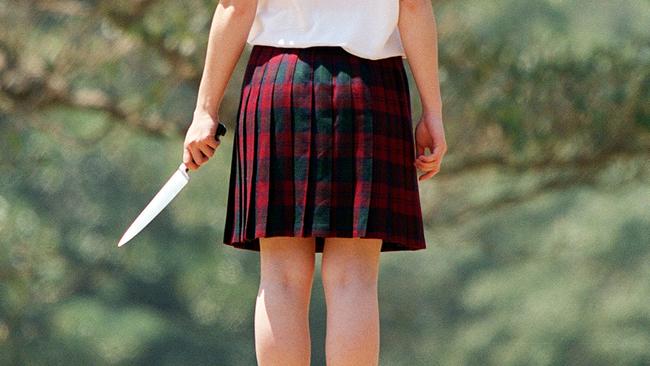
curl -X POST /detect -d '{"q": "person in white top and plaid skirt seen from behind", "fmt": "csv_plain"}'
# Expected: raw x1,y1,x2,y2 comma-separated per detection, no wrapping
183,0,447,366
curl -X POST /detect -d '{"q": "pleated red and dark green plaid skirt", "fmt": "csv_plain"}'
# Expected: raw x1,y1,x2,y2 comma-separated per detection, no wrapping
223,45,426,253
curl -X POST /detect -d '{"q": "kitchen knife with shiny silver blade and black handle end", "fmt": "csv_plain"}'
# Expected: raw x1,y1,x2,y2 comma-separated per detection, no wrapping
117,122,226,247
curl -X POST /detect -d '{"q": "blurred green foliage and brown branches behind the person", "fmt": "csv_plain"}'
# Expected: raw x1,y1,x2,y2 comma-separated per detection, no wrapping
0,0,650,366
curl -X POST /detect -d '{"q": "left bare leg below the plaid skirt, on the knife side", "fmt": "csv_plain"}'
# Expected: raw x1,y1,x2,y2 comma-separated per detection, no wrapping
255,236,316,366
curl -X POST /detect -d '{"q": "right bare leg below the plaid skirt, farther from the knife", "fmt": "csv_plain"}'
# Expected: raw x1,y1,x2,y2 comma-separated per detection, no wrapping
321,238,381,366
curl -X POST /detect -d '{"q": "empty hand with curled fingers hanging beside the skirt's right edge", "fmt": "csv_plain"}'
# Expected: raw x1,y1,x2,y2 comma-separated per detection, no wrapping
413,112,447,181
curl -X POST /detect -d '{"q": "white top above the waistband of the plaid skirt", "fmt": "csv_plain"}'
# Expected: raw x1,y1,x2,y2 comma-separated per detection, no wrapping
247,0,406,59
